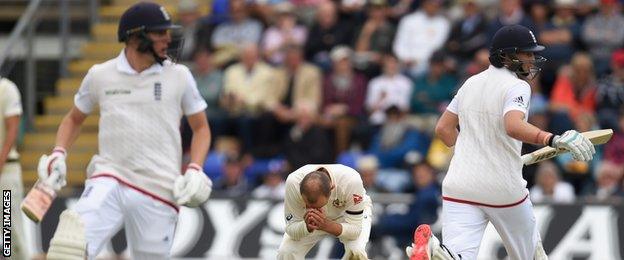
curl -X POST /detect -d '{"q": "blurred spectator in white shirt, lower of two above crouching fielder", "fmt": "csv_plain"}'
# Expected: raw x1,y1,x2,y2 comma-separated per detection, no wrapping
366,54,412,127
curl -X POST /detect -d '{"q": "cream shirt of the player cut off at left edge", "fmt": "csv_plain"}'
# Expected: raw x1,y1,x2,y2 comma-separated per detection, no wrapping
0,78,22,160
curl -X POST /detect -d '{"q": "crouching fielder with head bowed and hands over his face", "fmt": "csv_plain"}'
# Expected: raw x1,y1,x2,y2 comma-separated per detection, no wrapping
277,164,372,260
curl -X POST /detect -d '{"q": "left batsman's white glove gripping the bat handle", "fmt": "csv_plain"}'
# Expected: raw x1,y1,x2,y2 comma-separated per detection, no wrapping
37,147,67,191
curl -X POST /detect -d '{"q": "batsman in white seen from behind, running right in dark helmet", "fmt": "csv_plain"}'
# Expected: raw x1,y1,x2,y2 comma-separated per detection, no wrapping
406,25,595,260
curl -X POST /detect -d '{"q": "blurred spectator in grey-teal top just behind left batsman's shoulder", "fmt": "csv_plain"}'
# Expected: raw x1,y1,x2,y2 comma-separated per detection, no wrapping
193,48,226,139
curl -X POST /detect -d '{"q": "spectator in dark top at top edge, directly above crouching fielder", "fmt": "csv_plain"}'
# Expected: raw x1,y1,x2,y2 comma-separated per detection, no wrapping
305,1,353,71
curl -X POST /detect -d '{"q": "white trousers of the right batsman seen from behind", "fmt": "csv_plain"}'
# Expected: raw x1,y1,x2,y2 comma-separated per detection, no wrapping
442,198,540,260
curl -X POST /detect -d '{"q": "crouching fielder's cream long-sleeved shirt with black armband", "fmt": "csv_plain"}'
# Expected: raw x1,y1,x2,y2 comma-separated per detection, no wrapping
284,164,371,240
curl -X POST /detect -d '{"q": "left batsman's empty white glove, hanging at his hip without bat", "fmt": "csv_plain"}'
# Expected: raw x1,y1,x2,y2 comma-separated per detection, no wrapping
173,163,212,207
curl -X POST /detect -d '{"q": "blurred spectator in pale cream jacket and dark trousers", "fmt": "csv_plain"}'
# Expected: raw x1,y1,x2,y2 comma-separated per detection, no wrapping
222,44,276,152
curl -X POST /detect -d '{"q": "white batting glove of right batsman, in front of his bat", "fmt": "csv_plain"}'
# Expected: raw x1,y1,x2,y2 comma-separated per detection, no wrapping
552,130,596,161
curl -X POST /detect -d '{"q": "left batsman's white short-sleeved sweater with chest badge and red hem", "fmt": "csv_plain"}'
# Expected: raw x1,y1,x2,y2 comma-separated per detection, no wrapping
74,50,207,203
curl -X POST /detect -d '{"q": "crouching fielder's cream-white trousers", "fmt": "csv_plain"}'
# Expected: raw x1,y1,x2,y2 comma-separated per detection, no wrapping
278,200,372,260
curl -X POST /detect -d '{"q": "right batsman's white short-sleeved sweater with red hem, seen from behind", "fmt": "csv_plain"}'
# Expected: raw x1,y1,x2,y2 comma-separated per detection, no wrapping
442,66,531,206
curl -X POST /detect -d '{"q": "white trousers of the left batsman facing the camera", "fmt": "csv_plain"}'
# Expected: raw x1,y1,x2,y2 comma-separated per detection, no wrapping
74,177,178,260
